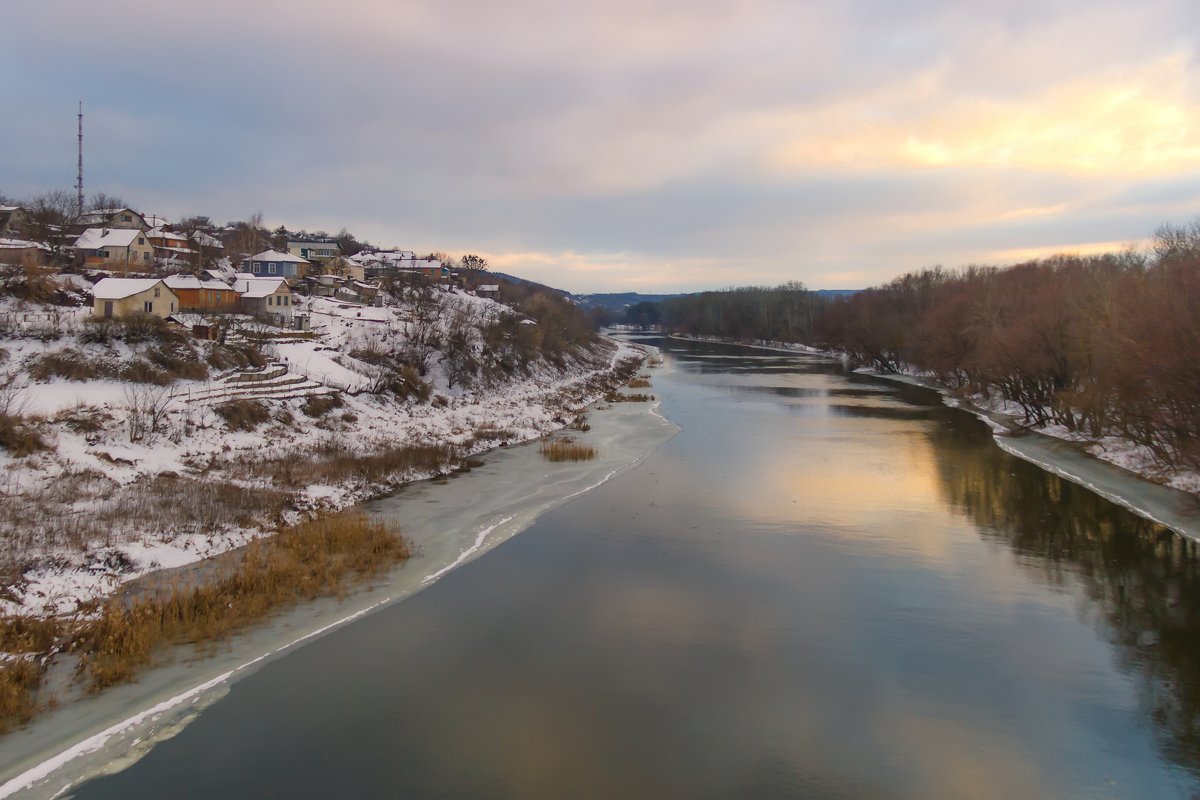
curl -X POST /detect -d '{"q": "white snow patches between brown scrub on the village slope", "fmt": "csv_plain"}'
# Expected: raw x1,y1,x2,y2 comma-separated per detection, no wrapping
0,291,641,614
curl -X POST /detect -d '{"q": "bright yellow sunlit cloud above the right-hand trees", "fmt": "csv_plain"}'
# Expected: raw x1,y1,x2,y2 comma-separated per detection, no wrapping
768,54,1200,176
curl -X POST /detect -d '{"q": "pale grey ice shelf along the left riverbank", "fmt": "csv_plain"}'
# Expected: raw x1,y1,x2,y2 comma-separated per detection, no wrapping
0,352,678,798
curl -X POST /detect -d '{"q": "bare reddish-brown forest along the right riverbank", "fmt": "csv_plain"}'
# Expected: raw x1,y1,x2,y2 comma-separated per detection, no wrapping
660,221,1200,470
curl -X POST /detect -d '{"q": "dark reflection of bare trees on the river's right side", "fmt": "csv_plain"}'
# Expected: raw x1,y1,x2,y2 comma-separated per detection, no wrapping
929,414,1200,774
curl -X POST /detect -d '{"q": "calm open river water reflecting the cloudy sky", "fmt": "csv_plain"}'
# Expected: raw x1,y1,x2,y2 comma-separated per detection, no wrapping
60,341,1200,800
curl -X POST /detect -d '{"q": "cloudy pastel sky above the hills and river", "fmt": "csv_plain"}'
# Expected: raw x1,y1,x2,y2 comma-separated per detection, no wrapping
0,0,1200,293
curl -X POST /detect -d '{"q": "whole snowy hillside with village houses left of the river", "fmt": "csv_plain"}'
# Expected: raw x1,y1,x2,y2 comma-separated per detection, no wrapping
0,195,642,615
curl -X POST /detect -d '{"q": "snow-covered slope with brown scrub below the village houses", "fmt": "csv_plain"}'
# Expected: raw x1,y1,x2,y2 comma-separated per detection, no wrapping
0,291,642,615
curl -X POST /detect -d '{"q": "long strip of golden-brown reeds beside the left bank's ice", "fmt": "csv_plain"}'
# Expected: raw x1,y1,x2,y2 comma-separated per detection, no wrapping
73,513,410,691
